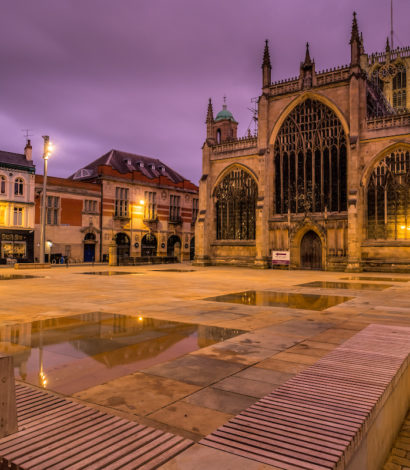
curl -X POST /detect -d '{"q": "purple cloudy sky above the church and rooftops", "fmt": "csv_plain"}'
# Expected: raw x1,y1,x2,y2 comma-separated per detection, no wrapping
0,0,410,182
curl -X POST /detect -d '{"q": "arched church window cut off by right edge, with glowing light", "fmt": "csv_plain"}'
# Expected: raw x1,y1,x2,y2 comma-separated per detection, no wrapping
367,148,410,240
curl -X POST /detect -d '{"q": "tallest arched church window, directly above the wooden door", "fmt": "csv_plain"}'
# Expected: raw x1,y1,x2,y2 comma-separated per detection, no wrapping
274,99,347,214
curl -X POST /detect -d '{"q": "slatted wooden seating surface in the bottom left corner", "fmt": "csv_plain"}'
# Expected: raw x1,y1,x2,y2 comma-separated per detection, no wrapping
0,384,193,470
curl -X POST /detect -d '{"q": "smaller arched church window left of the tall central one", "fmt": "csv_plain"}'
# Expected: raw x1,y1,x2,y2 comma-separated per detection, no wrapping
214,168,258,240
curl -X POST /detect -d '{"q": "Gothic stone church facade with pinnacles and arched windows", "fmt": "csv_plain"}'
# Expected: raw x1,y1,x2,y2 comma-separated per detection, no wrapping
195,15,410,272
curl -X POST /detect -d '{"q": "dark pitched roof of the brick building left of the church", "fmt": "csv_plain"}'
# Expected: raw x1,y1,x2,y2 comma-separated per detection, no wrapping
70,149,187,183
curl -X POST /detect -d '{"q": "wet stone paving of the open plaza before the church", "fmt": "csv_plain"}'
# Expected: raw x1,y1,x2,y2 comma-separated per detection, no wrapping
0,263,410,470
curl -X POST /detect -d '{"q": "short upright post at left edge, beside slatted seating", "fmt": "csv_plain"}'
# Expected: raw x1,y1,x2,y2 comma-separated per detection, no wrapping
0,354,18,438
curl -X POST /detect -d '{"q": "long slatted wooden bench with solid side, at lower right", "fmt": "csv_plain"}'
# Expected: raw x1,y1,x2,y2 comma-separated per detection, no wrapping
200,325,410,470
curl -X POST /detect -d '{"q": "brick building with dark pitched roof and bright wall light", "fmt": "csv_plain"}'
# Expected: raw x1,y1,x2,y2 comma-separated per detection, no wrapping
70,150,198,262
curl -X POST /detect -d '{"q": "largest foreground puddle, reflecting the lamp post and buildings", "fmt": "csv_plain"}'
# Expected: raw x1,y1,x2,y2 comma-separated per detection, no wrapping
0,312,244,394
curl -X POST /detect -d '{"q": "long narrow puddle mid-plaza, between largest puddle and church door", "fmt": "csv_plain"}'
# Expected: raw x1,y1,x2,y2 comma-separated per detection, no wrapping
205,290,353,310
